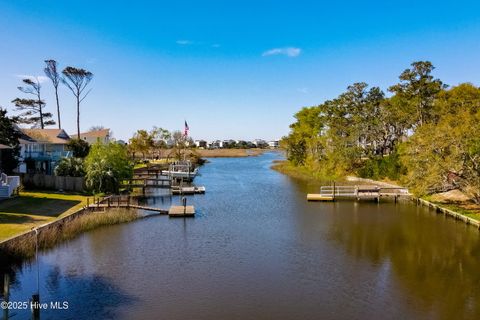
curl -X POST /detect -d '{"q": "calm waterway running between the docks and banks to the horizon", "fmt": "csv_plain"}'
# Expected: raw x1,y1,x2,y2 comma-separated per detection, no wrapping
2,153,480,319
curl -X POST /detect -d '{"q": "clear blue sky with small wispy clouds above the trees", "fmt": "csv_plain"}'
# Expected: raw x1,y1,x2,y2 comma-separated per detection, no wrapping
0,0,480,140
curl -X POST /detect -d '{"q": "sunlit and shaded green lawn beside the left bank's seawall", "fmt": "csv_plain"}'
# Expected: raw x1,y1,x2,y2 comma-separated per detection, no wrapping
0,191,87,240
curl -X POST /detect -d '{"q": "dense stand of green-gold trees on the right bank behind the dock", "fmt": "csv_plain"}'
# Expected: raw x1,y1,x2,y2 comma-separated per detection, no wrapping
281,61,480,203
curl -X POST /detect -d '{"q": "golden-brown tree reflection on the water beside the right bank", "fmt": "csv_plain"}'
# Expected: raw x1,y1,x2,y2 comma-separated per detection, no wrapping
329,203,480,319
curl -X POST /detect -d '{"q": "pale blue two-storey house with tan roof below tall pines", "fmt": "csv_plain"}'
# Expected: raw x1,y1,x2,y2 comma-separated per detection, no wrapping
17,129,72,174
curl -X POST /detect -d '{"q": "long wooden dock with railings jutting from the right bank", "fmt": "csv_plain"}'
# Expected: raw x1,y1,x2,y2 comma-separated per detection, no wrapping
307,185,410,202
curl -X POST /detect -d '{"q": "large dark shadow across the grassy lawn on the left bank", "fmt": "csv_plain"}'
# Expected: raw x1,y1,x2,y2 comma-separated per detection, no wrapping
0,196,81,217
